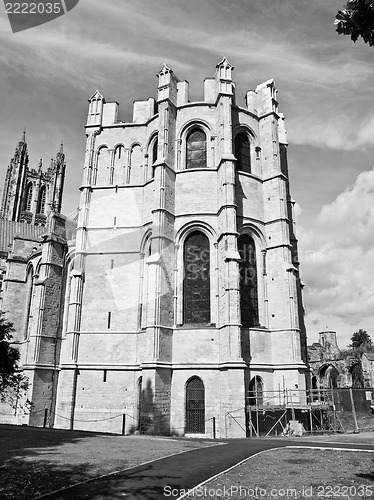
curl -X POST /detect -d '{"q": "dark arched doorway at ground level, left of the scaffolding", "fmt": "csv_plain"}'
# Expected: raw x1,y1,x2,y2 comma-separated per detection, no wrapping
185,377,205,434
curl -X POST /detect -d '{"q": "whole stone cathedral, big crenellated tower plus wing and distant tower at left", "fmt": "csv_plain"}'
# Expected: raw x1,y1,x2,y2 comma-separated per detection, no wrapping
0,58,308,437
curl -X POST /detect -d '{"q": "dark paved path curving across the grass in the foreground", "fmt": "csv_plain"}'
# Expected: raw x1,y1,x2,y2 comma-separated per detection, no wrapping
36,438,374,500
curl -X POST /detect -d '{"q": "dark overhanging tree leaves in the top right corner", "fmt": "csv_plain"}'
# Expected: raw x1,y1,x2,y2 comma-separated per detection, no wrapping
334,0,374,46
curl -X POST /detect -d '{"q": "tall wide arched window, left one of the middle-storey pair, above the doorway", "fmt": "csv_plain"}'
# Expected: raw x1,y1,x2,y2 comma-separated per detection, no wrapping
183,231,210,324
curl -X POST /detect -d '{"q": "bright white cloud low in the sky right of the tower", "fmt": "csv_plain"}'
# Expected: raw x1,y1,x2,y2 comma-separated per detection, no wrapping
300,169,374,340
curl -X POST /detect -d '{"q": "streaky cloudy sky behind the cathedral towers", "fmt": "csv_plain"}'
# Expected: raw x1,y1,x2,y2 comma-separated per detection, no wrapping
0,0,374,347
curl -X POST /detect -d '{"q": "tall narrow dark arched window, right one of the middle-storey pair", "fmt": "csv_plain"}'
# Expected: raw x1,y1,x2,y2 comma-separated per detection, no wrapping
238,234,259,328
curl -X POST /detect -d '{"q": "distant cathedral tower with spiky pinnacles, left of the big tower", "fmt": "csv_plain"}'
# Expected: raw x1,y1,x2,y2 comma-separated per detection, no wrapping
0,132,66,226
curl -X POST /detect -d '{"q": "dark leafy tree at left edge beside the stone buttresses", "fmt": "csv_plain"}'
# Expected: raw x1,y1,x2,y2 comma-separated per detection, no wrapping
0,311,28,405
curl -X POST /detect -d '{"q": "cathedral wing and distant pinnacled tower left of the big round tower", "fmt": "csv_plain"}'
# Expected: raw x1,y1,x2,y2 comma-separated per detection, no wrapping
0,138,76,425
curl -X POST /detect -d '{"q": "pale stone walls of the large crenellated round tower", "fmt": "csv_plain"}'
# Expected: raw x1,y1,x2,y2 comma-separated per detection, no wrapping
54,59,306,436
